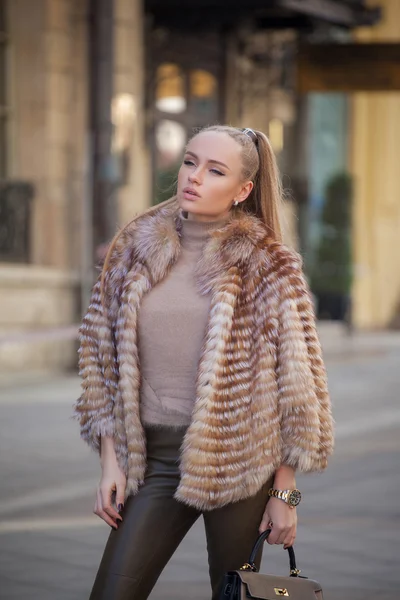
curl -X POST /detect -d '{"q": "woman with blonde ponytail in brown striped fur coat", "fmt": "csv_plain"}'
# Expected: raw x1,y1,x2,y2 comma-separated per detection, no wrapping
76,126,333,600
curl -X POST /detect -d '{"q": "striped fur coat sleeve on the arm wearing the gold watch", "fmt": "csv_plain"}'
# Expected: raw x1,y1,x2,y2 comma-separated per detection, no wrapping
277,252,333,472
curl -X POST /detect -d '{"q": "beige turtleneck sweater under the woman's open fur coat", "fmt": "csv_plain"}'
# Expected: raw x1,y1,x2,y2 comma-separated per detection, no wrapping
138,215,230,427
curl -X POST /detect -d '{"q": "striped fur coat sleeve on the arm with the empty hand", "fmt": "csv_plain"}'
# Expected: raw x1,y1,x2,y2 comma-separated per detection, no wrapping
75,277,118,451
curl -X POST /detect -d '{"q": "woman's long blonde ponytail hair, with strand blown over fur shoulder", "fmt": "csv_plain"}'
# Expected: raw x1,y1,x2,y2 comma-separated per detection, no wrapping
100,125,283,299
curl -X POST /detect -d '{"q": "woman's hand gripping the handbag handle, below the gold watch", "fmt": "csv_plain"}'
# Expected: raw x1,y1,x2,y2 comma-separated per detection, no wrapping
259,498,297,549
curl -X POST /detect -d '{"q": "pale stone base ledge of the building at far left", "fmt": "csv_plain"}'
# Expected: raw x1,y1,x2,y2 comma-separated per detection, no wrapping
0,265,78,375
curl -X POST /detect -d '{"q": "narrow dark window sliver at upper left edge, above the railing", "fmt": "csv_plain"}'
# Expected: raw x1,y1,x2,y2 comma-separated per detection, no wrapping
0,0,8,179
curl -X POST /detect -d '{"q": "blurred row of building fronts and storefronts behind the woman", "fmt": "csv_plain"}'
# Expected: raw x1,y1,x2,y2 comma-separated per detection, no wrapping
0,0,400,370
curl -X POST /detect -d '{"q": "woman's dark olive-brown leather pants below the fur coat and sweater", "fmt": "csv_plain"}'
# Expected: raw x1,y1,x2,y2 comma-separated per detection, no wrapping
90,427,272,600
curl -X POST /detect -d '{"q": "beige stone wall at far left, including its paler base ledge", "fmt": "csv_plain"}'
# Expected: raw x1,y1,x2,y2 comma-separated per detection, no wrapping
0,0,87,372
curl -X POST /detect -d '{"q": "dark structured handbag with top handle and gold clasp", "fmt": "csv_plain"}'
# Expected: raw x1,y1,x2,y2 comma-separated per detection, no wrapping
219,529,323,600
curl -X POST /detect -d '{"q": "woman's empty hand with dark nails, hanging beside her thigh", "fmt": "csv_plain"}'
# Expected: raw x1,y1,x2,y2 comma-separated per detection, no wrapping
93,460,126,529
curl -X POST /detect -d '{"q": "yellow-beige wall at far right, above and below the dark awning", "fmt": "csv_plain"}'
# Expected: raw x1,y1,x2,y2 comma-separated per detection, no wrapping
351,0,400,328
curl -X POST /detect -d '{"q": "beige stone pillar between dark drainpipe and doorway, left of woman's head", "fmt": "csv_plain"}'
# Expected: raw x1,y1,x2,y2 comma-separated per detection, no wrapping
114,0,151,225
